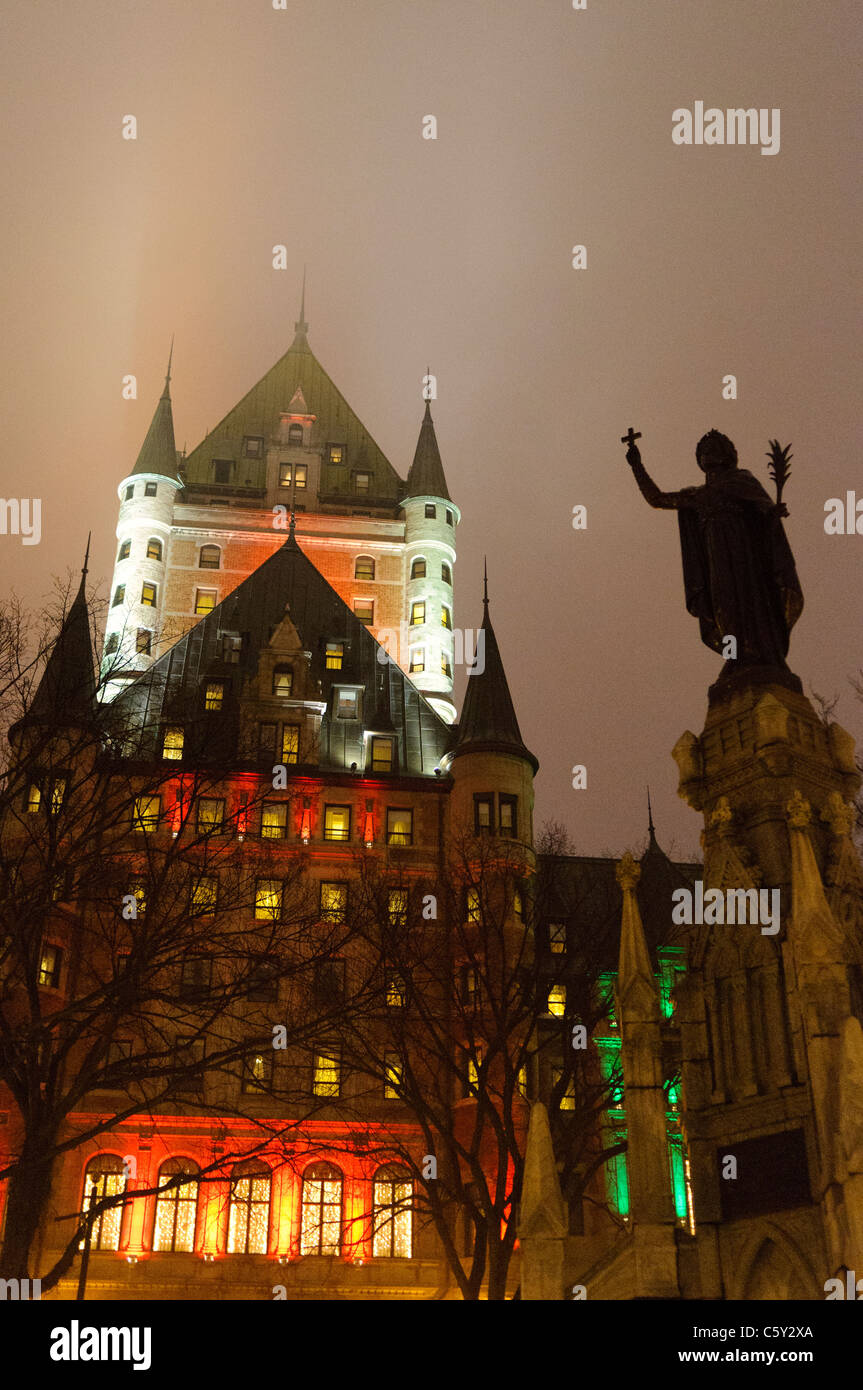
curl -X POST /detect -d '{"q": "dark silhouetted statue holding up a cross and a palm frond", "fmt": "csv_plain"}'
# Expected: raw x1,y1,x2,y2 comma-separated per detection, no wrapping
621,430,803,684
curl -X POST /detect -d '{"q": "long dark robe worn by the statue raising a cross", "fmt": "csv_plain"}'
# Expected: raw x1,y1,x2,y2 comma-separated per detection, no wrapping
675,468,803,666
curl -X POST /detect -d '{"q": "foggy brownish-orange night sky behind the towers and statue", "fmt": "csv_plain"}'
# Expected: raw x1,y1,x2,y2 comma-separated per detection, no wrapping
0,0,863,853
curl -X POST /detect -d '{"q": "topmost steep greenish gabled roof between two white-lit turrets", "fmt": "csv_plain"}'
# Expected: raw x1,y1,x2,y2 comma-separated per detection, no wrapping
183,317,404,505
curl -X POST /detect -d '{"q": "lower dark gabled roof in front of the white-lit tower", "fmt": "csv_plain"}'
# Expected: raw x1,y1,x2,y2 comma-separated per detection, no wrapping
111,535,450,777
